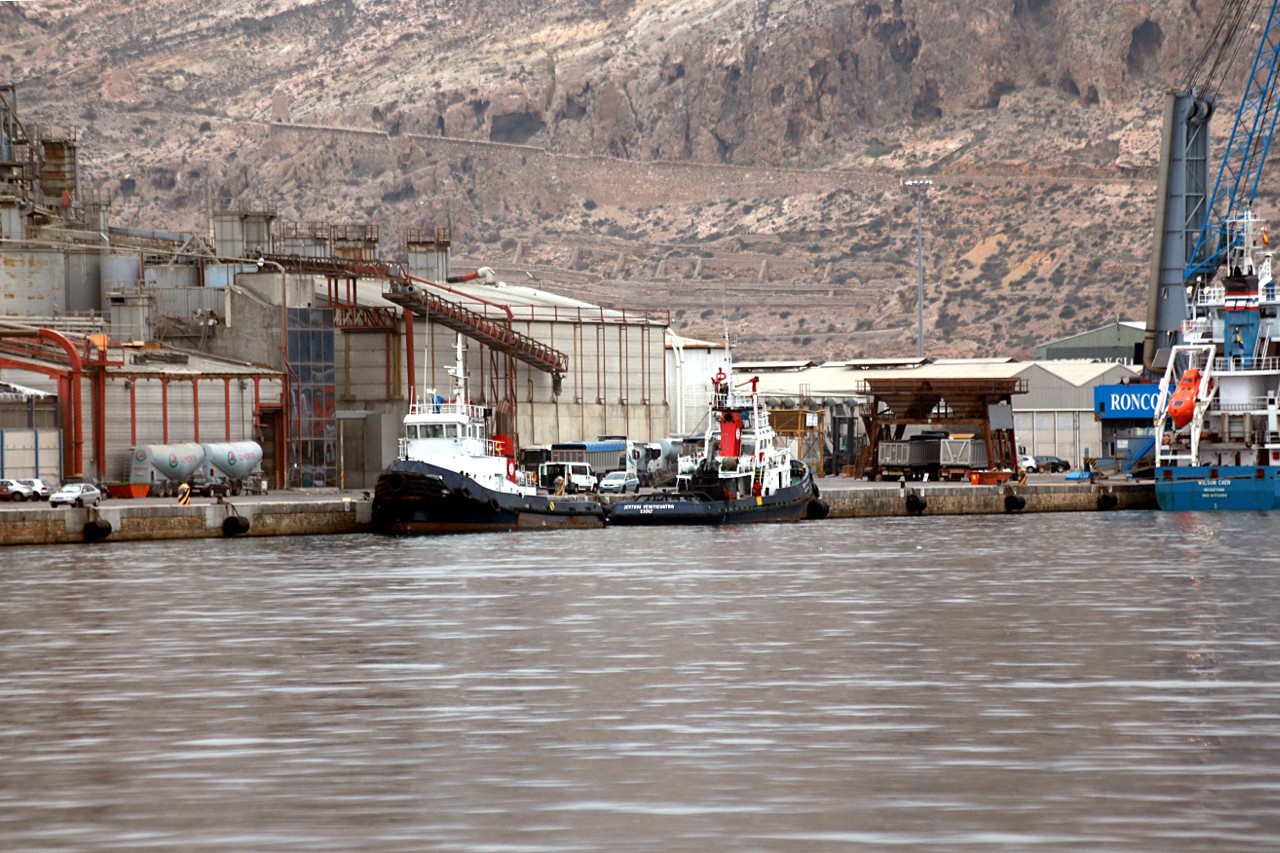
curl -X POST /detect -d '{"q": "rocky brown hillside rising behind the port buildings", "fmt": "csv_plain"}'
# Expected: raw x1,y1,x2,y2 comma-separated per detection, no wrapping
0,0,1244,359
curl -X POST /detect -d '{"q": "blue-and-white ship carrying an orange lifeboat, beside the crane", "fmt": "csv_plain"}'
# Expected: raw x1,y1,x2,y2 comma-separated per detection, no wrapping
1156,214,1280,510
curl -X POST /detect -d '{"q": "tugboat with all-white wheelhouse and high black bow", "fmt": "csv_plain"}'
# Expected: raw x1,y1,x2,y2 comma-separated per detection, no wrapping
372,334,604,534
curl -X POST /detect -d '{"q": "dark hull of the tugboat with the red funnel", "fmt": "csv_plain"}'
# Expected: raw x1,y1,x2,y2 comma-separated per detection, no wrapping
609,475,828,526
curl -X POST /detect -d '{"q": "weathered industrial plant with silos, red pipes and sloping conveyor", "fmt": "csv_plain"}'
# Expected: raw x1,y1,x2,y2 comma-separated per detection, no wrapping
0,88,671,488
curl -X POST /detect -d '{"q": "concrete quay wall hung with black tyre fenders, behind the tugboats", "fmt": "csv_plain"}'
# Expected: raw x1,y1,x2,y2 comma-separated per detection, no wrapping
0,476,1156,546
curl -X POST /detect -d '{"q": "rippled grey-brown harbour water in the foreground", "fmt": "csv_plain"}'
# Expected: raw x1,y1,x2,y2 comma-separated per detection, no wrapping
0,512,1280,853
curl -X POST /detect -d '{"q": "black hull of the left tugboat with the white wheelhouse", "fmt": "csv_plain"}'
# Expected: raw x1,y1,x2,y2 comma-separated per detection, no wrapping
372,460,604,535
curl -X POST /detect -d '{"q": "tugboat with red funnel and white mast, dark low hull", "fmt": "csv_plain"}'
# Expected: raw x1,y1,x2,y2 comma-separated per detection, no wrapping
609,339,829,526
